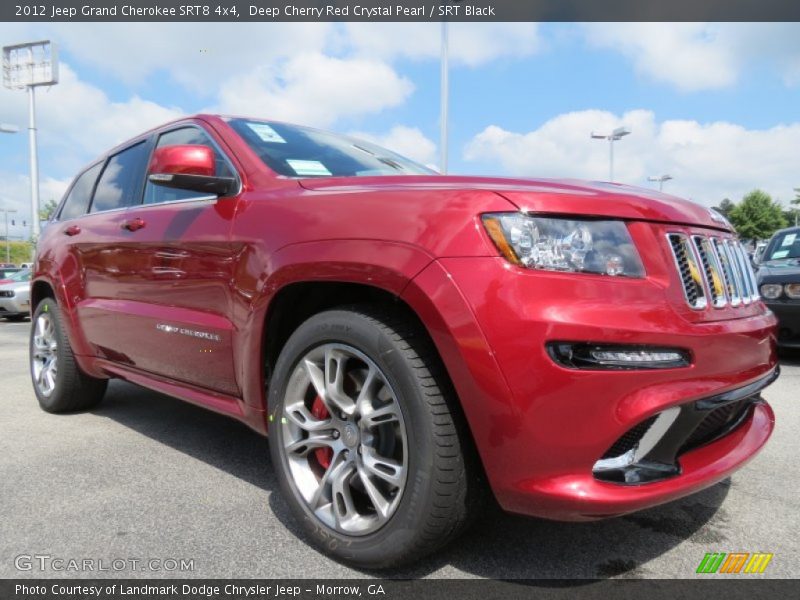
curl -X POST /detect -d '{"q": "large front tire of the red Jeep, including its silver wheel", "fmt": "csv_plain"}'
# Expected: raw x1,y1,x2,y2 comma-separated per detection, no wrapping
269,306,484,569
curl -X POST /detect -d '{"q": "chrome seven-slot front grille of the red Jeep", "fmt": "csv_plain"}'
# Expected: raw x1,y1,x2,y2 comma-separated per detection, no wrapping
667,233,758,310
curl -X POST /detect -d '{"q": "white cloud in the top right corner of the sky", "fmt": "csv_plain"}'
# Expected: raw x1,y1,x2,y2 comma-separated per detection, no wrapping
583,23,800,91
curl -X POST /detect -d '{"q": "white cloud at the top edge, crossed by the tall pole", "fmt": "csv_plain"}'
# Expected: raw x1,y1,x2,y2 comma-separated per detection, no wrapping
339,23,542,67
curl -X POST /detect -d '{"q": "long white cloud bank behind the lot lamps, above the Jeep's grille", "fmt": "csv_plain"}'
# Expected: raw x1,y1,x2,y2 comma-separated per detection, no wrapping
465,110,800,205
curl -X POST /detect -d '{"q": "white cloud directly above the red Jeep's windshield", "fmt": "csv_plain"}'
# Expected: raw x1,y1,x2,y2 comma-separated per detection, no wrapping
217,53,414,126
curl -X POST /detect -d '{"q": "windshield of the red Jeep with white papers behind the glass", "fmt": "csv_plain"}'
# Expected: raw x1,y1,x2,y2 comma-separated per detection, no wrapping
228,119,435,177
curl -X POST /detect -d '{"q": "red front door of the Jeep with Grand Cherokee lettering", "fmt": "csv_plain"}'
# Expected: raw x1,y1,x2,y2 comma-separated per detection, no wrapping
84,124,238,395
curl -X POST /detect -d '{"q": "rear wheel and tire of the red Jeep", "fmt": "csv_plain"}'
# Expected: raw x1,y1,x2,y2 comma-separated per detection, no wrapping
29,298,108,413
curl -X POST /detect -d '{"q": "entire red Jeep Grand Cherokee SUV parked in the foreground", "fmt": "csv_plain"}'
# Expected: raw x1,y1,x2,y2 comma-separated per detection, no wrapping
30,115,777,567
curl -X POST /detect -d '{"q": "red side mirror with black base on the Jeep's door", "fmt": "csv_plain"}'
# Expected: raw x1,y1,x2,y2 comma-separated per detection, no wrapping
147,144,236,196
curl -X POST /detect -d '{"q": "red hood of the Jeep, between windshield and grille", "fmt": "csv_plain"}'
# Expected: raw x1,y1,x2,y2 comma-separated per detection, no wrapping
299,175,732,231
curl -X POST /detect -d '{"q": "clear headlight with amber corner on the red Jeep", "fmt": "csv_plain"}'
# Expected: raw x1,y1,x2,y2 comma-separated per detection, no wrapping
483,213,644,277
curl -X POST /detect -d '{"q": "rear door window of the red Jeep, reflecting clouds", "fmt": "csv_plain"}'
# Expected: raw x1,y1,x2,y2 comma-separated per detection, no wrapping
92,142,147,212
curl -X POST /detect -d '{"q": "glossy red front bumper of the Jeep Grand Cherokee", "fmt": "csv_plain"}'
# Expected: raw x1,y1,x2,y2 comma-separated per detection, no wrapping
407,257,777,520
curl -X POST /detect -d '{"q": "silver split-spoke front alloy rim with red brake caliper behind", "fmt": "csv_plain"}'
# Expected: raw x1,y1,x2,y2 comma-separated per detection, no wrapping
281,343,408,535
